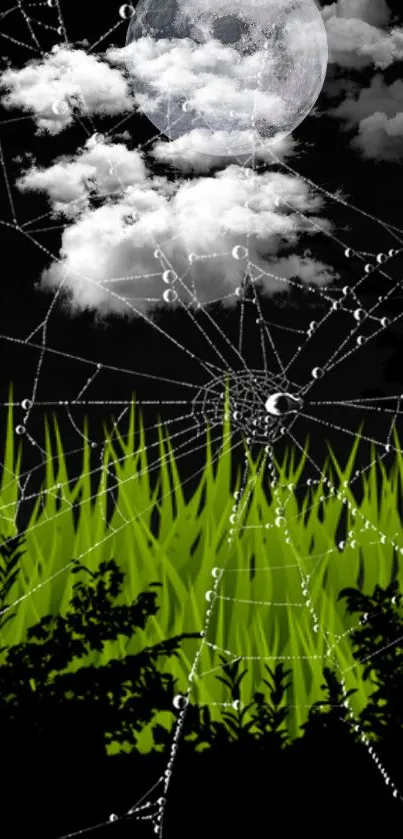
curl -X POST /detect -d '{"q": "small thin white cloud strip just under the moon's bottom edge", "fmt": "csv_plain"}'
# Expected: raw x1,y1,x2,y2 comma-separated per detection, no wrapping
150,128,298,173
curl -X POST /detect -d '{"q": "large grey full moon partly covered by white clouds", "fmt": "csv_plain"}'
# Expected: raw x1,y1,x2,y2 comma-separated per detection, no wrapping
126,0,328,157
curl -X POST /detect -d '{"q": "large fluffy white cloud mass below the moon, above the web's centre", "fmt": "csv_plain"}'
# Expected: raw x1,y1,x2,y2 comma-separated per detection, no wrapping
21,144,335,315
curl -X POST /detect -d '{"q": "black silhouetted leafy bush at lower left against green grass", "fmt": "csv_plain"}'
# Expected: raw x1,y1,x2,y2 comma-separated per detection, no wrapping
0,559,200,754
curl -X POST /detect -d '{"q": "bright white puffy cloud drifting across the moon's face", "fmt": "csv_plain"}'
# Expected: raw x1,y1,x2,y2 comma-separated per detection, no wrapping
106,36,284,130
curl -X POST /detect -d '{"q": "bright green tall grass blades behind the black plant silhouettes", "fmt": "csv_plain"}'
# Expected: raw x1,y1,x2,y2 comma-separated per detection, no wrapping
0,390,403,748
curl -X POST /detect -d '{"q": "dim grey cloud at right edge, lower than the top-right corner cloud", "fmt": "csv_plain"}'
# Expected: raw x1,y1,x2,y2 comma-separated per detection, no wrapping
329,73,403,161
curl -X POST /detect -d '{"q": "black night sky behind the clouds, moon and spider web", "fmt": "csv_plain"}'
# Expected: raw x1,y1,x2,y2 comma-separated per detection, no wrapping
0,0,403,524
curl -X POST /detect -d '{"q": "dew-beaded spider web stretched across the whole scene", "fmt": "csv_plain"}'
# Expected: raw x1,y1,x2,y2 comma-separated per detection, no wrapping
0,0,403,836
